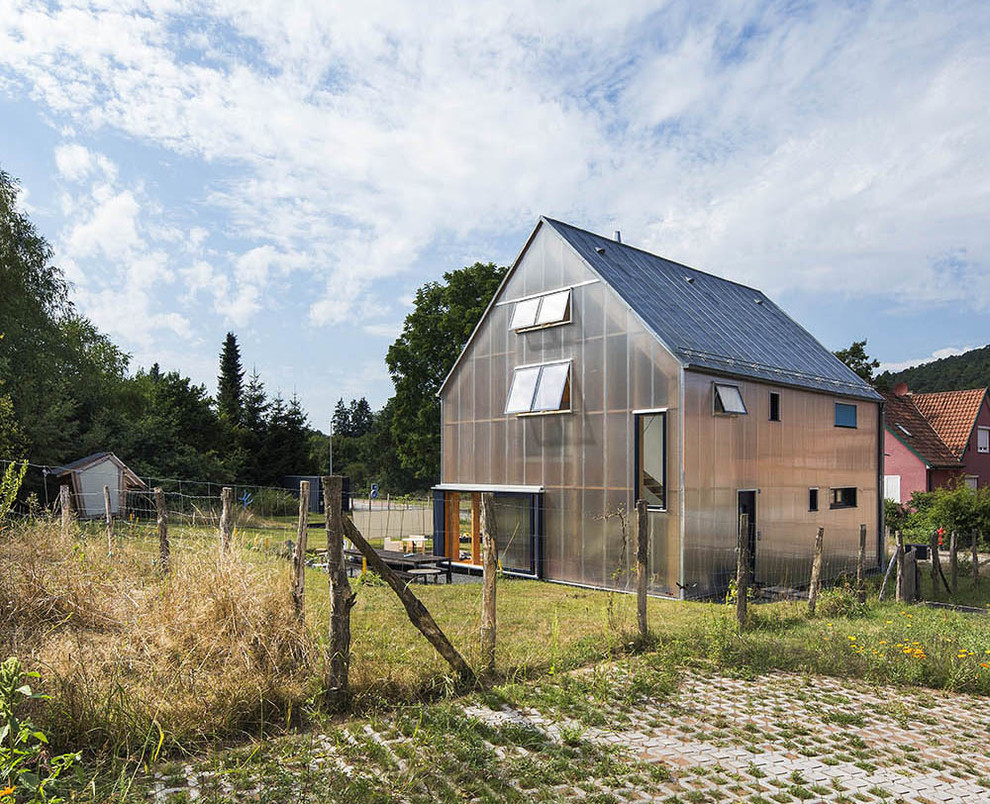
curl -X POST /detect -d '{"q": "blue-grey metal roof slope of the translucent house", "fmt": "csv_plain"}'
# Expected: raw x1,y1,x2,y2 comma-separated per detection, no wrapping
543,218,881,401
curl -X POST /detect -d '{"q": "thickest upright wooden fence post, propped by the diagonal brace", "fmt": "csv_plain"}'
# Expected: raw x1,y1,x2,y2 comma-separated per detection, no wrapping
323,475,357,708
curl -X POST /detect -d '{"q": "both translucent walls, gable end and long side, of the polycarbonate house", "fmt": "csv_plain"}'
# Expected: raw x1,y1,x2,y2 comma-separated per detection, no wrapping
437,224,881,597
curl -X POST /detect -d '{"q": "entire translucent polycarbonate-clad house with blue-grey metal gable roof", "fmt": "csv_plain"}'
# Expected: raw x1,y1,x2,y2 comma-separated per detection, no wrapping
434,218,882,597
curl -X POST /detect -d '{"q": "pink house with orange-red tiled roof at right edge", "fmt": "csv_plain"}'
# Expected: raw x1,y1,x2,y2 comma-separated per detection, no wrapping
884,383,990,504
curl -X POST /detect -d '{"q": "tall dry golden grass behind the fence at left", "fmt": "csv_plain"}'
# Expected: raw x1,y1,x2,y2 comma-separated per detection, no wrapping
0,522,322,758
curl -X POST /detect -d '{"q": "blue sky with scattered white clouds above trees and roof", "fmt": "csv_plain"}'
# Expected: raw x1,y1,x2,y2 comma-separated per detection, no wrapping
0,0,990,430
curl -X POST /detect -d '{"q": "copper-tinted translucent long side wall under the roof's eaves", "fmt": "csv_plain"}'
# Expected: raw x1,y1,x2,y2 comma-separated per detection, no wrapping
683,371,880,596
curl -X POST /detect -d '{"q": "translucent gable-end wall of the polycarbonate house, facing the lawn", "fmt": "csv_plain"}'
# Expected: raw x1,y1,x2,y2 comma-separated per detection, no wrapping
442,226,681,595
